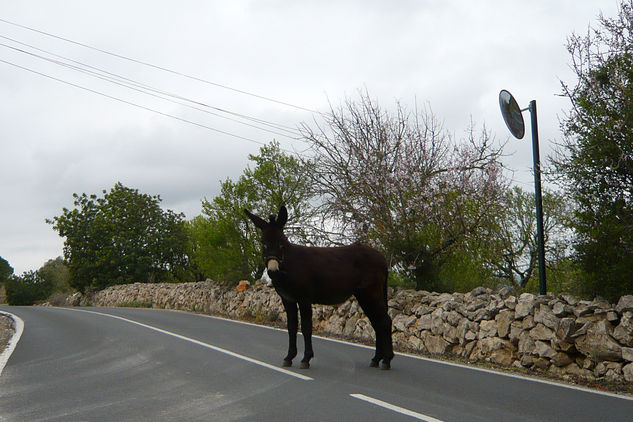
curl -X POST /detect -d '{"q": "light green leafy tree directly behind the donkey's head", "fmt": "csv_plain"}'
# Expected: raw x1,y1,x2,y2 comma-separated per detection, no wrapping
188,142,313,282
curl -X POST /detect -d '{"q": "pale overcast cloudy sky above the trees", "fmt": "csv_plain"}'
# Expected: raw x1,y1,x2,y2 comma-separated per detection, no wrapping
0,0,617,273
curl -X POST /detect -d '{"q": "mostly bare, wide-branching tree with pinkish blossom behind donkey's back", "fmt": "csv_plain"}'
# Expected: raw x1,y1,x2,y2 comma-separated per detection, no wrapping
303,94,506,290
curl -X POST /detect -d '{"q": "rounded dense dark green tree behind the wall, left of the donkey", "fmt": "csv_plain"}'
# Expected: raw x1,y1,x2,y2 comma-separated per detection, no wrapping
47,183,187,291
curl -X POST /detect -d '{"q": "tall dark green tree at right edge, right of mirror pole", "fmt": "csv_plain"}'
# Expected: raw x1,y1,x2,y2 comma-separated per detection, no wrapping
552,0,633,299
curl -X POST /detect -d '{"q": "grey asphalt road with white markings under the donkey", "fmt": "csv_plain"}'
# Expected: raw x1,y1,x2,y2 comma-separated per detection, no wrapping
0,306,633,422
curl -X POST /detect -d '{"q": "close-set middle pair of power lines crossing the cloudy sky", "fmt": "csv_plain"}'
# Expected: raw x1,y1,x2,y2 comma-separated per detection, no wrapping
0,35,301,140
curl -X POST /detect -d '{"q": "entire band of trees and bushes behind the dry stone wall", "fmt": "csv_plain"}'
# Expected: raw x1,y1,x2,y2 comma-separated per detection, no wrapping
0,0,633,304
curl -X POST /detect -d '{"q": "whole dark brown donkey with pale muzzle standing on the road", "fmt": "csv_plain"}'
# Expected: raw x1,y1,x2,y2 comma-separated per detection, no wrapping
244,206,393,369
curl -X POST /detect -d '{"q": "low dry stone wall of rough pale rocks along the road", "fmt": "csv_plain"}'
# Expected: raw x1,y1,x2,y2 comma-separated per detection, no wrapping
67,280,633,383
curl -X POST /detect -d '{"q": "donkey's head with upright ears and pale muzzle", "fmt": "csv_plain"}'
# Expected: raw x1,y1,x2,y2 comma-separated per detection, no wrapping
244,205,289,271
